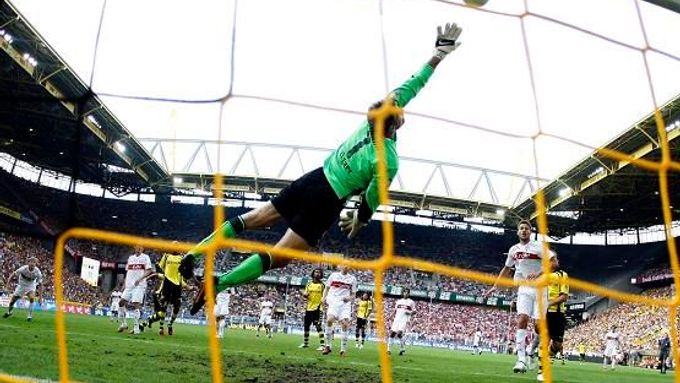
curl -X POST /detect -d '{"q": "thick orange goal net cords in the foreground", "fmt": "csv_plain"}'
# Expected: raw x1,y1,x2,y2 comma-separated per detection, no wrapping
0,2,680,383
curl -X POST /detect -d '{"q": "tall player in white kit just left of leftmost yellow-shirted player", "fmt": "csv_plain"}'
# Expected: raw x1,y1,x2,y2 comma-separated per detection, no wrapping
118,245,153,335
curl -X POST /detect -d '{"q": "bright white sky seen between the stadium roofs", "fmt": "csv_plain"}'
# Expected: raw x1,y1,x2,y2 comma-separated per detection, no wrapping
12,0,680,205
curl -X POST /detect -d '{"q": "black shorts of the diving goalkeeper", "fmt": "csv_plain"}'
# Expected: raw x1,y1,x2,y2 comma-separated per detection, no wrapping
271,168,345,246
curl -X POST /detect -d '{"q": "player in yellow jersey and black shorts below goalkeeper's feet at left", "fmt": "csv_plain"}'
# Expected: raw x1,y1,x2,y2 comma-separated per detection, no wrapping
136,253,186,335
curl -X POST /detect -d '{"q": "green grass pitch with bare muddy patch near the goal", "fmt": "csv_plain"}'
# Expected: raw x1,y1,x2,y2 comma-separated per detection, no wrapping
0,310,673,383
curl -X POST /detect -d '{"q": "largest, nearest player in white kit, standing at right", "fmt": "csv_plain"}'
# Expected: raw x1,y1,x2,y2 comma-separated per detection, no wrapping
484,220,552,373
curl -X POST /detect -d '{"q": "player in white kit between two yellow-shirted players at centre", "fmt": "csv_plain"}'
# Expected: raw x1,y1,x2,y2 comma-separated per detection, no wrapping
321,266,357,356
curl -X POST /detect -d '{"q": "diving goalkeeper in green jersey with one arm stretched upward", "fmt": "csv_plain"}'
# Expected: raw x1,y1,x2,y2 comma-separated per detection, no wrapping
180,23,462,315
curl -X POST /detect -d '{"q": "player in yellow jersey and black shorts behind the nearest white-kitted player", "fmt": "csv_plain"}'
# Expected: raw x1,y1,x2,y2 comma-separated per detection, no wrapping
538,253,569,381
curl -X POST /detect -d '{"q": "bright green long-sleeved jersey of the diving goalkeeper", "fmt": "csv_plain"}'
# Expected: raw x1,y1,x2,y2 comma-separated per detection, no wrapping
323,65,434,218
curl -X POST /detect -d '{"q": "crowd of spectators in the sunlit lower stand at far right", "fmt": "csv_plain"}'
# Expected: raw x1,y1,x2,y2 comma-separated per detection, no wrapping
565,286,674,353
